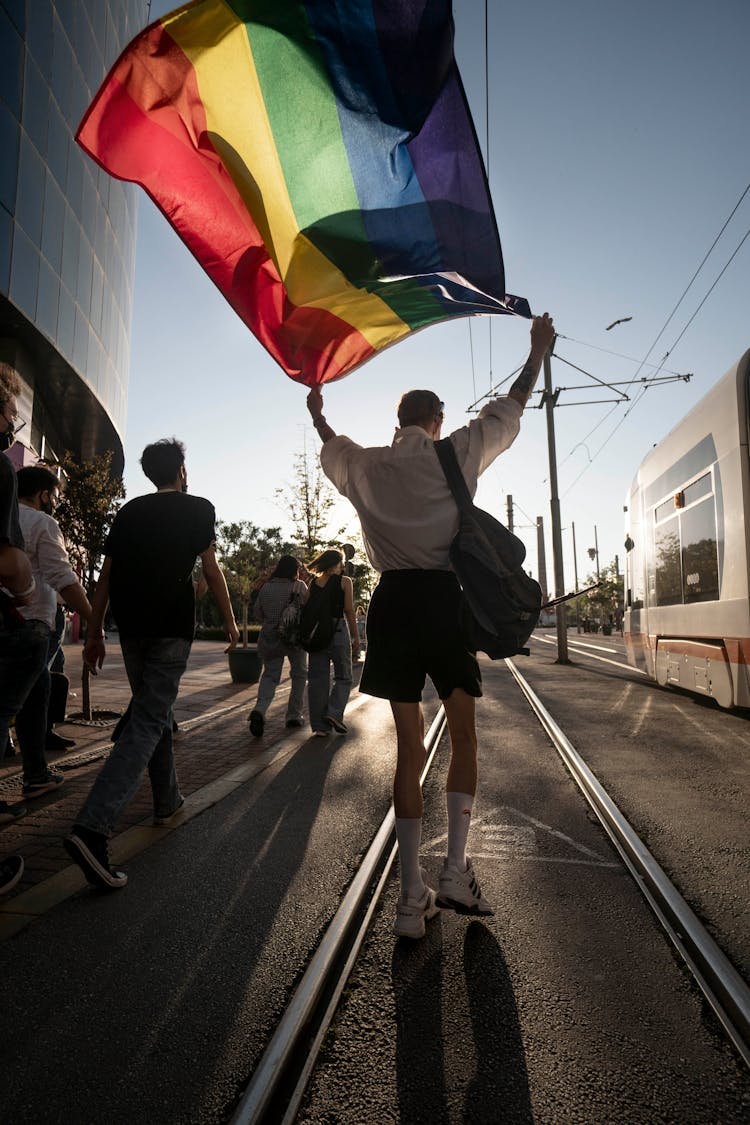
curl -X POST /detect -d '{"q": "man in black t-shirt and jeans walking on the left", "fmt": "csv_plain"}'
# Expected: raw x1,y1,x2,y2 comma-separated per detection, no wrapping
65,439,240,888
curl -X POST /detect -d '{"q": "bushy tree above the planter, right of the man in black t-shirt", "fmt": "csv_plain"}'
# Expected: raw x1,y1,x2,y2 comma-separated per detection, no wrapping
216,520,293,648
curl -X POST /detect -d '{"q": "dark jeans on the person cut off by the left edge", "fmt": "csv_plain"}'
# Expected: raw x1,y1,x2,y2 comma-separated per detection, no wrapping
0,621,51,784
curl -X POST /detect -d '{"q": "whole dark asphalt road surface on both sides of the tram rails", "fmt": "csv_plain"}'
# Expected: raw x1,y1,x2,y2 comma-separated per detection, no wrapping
0,632,750,1125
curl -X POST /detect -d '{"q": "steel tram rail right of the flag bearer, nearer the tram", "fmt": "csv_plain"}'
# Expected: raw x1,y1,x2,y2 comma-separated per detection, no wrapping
505,659,750,1067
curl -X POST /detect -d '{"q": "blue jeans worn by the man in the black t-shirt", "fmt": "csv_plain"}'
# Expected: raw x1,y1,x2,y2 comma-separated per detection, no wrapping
75,637,191,836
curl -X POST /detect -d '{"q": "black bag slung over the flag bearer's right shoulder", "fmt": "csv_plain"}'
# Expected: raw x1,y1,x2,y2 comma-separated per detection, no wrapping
435,438,542,660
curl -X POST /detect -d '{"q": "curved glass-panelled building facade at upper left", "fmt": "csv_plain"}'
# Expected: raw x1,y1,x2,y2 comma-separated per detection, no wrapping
0,0,148,471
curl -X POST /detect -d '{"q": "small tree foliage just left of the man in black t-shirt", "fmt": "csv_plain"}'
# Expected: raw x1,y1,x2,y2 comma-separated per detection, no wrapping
55,450,125,597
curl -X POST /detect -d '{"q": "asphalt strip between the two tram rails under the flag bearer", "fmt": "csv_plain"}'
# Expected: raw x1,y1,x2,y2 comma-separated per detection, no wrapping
299,656,750,1125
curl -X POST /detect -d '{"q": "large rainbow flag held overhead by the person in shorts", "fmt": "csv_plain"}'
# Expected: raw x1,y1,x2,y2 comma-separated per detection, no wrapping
78,0,531,386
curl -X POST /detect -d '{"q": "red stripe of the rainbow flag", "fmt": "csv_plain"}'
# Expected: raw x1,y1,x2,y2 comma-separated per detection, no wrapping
76,25,374,386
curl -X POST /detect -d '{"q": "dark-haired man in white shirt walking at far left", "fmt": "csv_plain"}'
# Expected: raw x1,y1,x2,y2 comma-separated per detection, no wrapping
16,465,91,798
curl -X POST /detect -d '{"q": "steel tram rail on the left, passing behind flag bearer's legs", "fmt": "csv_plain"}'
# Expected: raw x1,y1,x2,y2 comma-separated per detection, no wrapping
232,704,445,1125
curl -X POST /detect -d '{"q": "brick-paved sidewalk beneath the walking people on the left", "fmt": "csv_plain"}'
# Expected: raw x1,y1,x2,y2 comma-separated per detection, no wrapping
0,641,361,922
